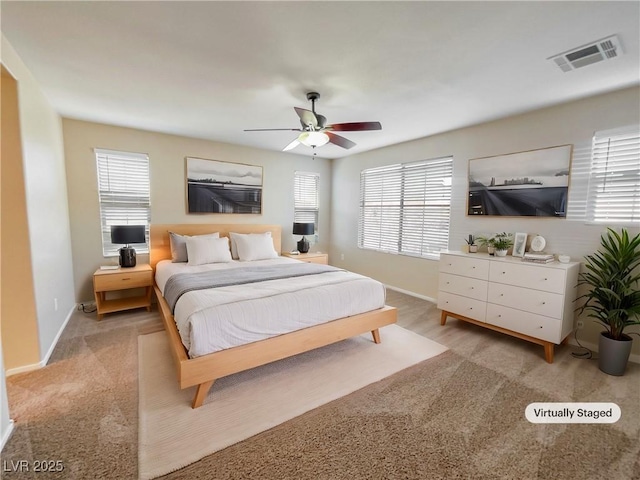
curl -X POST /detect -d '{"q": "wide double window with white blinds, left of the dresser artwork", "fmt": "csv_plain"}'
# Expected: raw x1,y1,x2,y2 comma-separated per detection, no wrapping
358,157,453,257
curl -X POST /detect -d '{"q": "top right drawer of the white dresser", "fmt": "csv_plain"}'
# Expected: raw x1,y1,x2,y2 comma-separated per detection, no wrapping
489,261,565,294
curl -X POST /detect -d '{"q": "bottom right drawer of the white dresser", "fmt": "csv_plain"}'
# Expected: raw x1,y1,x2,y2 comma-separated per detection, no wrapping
485,303,562,344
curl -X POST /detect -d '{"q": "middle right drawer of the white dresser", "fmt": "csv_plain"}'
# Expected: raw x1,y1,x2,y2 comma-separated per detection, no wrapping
487,283,564,320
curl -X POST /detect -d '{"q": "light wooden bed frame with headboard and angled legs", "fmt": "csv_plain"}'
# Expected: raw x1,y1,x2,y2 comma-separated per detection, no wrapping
149,224,397,408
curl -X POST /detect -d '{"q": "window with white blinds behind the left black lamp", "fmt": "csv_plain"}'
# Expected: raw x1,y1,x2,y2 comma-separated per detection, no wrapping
95,149,151,257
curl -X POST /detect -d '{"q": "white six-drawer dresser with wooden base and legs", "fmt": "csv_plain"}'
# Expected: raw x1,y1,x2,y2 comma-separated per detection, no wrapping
438,252,580,363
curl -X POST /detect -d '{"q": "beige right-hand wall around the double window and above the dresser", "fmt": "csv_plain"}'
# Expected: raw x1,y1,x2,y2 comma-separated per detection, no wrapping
330,87,640,354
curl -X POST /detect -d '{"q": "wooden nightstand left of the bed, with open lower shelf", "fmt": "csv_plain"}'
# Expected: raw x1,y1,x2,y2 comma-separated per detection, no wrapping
93,264,153,320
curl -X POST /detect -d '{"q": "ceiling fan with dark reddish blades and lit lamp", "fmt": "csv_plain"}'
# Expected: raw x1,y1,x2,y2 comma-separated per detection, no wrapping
245,92,382,152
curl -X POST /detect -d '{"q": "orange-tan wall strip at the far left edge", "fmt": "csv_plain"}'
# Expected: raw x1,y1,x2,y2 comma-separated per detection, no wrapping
0,66,40,369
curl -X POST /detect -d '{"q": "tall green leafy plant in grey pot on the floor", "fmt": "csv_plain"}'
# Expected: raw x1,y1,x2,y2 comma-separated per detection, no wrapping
578,228,640,375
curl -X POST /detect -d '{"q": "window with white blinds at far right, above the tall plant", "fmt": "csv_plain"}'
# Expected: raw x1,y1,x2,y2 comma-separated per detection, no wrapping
587,125,640,225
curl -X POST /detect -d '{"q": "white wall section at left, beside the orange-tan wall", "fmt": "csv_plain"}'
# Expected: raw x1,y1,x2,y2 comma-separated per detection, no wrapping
0,36,75,373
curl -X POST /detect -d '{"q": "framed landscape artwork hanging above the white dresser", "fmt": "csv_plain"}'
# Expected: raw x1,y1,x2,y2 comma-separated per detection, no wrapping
467,145,573,218
